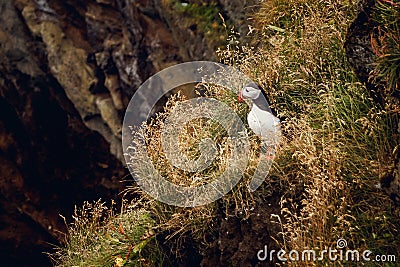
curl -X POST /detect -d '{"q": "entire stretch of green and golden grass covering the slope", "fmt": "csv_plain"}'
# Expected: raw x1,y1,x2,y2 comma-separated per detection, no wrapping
53,0,400,266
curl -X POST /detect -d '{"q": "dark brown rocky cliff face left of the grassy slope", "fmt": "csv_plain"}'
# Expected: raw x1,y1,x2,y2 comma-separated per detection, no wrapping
0,0,256,266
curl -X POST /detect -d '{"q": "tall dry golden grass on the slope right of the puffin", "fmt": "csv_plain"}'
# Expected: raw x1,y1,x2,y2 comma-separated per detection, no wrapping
219,0,400,266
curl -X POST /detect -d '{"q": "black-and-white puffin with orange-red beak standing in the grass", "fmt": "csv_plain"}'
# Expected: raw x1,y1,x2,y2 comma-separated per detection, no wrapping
238,83,280,160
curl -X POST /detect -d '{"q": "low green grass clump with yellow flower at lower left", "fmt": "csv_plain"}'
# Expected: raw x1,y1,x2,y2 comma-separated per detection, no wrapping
51,201,166,267
